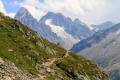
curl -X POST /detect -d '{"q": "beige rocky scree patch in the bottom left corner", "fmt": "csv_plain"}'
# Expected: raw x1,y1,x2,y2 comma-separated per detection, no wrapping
0,58,33,80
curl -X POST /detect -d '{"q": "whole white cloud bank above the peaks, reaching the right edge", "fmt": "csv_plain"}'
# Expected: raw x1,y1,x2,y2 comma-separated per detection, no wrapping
12,0,120,24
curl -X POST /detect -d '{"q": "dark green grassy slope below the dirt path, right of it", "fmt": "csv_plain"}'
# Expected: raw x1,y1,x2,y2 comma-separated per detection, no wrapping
56,52,108,80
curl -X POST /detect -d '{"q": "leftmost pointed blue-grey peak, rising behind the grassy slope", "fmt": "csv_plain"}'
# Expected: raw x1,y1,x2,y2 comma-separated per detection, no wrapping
14,7,39,30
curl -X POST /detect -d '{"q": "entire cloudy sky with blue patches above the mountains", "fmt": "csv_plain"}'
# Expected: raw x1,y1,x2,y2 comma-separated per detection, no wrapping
0,0,120,25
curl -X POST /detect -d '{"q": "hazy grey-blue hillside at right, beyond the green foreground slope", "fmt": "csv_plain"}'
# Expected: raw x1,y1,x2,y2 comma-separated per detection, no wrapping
71,24,120,80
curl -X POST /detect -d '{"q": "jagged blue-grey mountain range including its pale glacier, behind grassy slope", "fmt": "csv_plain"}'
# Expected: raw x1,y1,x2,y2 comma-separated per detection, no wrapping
15,7,94,49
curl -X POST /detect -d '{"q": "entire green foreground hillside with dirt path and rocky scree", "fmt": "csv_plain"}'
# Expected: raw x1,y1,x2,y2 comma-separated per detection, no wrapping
0,13,110,80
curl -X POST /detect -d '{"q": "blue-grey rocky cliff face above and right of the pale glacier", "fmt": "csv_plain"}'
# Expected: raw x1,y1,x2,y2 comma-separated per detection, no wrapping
39,12,92,40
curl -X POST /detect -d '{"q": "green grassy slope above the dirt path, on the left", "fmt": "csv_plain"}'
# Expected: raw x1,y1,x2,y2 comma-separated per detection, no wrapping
0,13,66,74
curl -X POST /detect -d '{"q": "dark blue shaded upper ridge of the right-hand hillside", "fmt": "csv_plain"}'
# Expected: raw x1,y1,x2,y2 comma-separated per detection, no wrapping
70,23,120,53
